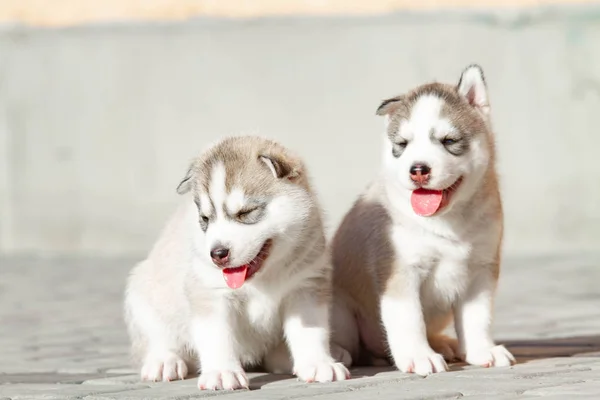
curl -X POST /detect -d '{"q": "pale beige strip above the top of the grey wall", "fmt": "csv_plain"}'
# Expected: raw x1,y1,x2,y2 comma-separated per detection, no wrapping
0,0,600,26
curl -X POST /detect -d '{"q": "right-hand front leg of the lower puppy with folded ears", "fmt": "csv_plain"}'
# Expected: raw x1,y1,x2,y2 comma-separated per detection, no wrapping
283,289,350,382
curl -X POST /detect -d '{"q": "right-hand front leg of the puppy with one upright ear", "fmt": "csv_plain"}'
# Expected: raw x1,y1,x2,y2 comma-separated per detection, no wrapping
454,266,515,367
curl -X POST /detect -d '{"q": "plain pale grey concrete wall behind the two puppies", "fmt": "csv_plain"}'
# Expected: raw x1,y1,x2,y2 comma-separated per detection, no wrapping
0,7,600,255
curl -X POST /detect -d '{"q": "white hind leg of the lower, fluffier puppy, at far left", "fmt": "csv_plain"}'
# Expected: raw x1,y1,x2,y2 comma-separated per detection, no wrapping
125,294,188,382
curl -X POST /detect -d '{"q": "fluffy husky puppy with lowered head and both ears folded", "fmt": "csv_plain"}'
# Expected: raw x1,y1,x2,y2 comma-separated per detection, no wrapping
125,136,349,390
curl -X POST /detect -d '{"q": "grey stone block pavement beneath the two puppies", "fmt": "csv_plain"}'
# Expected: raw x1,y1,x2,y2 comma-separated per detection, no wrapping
0,254,600,400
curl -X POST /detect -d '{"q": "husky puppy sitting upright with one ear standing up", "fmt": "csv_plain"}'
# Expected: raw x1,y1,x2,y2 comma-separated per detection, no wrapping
332,65,514,375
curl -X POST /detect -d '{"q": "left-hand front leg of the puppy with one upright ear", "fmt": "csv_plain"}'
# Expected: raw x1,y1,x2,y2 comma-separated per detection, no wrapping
381,268,448,376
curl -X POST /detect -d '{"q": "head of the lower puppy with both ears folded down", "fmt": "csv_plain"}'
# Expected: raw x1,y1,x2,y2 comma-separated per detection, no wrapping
177,136,313,288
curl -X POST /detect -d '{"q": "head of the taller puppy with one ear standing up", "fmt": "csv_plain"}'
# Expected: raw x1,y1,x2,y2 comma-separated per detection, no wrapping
377,65,493,216
